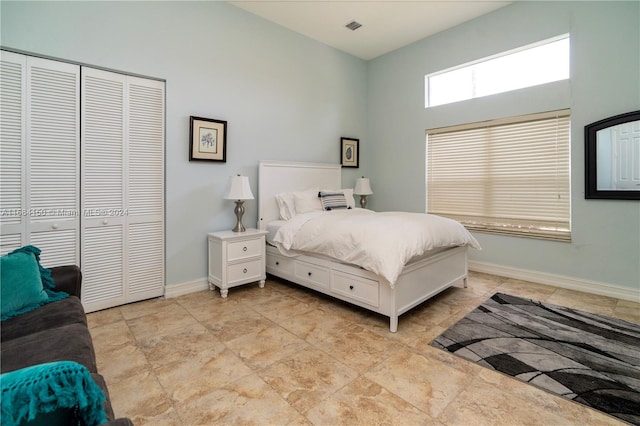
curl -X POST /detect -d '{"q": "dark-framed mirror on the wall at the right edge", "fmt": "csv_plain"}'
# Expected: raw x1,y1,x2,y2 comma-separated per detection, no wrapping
584,111,640,200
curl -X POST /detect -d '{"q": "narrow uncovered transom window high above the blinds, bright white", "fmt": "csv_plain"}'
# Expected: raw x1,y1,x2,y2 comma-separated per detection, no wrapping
425,35,569,108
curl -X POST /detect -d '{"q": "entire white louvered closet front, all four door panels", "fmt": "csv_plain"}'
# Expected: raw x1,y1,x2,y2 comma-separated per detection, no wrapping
0,51,165,312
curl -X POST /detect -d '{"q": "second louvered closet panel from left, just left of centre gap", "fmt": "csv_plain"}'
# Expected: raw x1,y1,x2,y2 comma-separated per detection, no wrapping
26,57,80,267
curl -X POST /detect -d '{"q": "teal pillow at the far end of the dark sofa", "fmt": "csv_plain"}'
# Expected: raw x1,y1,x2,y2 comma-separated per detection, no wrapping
0,252,49,317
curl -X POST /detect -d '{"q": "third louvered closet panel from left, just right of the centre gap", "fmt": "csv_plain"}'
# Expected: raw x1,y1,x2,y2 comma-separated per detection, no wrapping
81,67,126,312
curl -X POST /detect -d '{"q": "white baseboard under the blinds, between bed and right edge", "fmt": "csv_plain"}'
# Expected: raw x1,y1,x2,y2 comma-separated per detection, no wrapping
469,261,638,302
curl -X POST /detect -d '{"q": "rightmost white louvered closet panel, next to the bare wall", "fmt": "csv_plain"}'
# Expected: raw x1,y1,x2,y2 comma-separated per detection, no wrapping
127,77,164,302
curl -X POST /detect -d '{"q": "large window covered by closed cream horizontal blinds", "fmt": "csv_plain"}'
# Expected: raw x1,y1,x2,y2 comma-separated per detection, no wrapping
427,110,571,241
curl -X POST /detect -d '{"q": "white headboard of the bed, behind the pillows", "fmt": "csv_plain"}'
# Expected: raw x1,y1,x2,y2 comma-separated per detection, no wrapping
258,161,342,229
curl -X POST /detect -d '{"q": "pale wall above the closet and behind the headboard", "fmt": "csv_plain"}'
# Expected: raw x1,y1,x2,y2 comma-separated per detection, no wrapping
0,1,366,286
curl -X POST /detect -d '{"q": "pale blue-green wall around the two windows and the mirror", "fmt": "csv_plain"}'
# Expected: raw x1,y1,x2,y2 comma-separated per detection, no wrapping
363,1,640,290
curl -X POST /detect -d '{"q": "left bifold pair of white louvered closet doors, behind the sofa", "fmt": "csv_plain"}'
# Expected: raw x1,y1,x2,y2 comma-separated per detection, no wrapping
0,51,80,267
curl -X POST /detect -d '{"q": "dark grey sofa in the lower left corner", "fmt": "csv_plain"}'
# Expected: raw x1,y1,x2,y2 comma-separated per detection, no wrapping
0,266,133,426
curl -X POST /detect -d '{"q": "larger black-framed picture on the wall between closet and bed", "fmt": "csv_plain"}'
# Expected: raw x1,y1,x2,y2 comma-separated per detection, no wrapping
189,116,227,163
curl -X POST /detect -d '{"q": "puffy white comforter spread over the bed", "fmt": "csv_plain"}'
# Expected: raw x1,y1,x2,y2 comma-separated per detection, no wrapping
273,209,480,287
